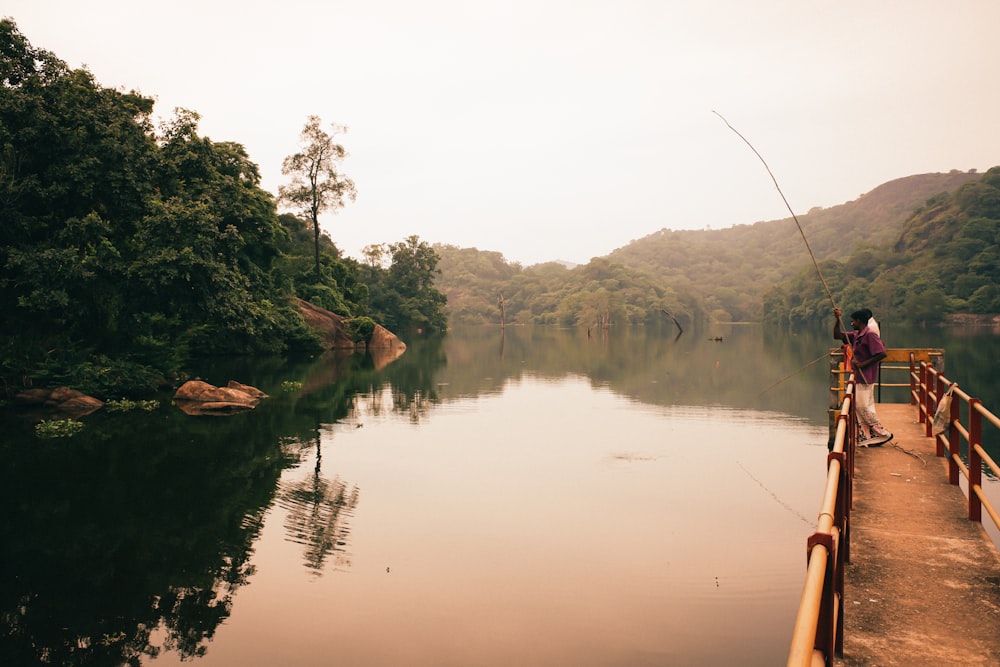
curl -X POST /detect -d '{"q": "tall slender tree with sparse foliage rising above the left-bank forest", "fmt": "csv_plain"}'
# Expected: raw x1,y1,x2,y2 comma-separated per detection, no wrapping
278,116,357,283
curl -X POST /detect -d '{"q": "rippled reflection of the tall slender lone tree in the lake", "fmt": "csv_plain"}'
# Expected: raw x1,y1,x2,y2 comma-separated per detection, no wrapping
278,434,360,575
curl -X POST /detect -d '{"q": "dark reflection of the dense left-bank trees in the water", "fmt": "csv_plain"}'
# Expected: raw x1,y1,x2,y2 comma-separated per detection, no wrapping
0,410,282,665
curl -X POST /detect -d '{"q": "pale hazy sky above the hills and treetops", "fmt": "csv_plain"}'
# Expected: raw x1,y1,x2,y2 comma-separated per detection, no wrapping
7,0,1000,264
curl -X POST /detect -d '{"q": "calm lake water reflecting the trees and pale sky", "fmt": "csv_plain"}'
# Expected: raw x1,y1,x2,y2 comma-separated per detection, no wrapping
0,325,1000,667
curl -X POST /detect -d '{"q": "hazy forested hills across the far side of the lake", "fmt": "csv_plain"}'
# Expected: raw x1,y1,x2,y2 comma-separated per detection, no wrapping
435,167,1000,327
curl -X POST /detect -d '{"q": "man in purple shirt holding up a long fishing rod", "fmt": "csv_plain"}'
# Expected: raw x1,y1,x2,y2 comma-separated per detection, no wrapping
833,306,892,447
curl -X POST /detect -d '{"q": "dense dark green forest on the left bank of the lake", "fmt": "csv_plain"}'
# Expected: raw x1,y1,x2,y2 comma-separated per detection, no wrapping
0,19,447,396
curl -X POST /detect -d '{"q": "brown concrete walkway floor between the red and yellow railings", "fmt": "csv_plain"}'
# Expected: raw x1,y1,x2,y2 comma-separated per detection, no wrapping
834,404,1000,667
